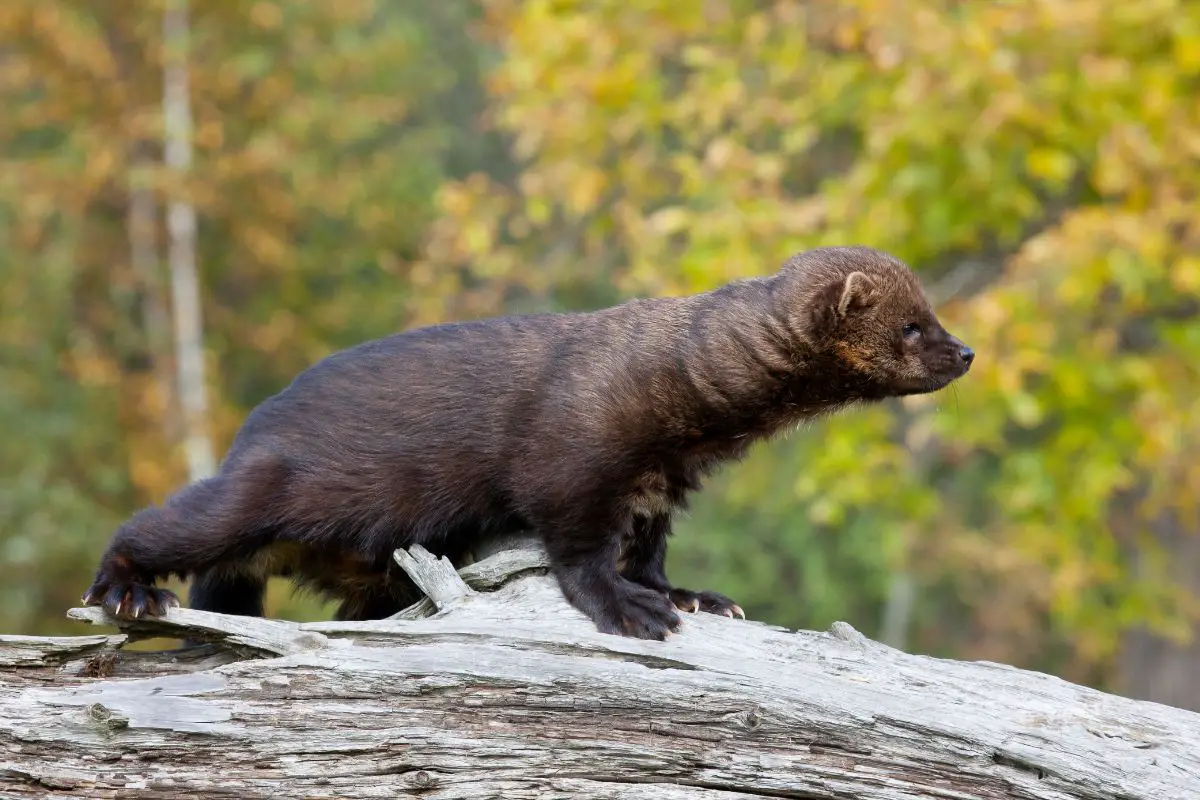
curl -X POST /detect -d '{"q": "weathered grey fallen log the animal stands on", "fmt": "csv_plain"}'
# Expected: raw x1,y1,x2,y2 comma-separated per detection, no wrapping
0,542,1200,800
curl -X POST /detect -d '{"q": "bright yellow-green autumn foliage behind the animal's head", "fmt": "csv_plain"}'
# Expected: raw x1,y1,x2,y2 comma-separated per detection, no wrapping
417,0,1200,671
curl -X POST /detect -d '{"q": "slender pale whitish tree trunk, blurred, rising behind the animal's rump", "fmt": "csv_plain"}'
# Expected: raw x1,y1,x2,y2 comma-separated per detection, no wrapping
162,0,216,481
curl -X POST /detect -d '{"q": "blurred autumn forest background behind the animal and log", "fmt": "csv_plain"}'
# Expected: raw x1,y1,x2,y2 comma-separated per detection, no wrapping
0,0,1200,709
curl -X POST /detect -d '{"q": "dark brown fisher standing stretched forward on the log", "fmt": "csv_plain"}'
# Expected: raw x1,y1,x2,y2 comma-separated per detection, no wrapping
84,247,973,639
